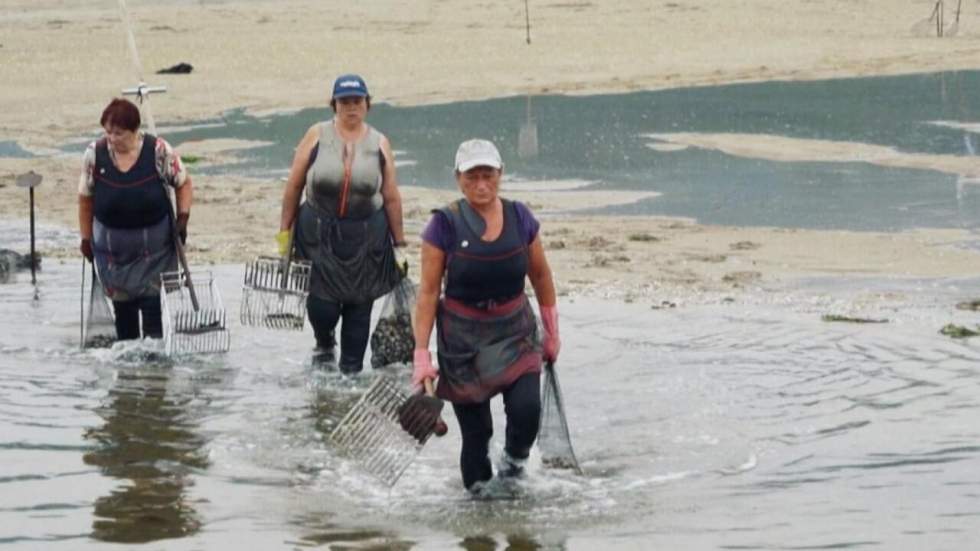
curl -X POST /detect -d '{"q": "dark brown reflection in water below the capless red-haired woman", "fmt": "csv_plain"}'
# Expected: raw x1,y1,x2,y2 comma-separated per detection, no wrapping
83,367,208,543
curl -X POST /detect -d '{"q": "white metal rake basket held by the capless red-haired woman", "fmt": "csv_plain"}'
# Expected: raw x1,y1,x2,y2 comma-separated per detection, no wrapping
160,271,231,356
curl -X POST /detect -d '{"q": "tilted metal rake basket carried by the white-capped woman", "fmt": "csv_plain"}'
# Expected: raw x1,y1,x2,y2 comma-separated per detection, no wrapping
330,375,429,487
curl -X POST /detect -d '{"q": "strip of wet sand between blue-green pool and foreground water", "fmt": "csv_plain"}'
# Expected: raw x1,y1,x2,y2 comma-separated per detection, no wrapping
0,154,980,302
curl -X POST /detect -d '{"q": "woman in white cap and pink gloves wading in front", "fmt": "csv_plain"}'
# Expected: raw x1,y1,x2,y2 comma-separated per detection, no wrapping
412,140,560,492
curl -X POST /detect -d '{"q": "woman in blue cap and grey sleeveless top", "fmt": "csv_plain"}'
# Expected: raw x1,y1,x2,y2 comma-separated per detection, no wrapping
276,75,405,373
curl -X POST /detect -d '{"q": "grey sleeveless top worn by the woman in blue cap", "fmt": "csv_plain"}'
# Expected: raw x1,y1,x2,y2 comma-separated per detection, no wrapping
306,119,384,219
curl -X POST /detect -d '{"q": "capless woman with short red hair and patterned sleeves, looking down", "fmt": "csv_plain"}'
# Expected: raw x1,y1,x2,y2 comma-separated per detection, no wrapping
78,98,193,340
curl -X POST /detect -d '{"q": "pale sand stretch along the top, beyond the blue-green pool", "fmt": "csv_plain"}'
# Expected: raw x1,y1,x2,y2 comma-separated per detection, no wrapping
0,0,980,147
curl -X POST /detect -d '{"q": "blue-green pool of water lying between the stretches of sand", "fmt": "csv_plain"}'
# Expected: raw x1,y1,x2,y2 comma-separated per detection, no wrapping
55,71,980,231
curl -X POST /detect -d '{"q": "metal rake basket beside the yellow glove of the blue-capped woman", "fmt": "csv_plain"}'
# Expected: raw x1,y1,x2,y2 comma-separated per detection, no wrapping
240,256,312,331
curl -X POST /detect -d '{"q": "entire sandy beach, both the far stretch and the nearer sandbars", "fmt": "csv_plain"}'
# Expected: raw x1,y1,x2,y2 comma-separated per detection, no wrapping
0,0,980,300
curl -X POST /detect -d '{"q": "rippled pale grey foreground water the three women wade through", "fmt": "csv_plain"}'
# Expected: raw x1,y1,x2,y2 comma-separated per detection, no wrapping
0,263,980,550
